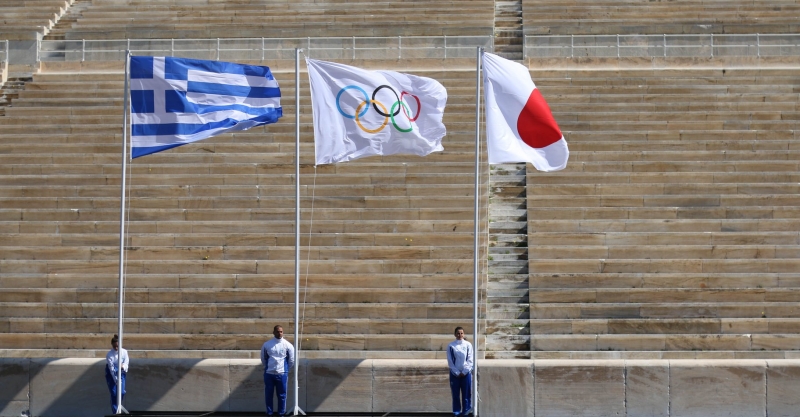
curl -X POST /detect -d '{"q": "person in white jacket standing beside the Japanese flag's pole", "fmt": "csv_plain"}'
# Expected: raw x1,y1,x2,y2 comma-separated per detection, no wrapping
447,326,475,416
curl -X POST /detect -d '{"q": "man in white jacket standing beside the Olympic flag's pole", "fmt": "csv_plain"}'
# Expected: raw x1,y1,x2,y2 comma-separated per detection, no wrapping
261,325,294,416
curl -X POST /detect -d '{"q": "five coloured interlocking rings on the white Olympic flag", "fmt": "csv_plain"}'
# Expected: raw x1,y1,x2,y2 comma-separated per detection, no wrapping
336,84,422,134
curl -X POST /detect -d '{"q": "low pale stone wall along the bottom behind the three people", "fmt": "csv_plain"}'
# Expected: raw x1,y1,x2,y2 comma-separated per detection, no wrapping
0,354,800,417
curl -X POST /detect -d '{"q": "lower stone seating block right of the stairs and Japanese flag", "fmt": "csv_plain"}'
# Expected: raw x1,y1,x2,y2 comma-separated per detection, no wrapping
526,69,800,358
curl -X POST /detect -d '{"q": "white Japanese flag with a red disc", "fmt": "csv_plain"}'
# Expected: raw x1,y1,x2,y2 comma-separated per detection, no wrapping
483,53,569,171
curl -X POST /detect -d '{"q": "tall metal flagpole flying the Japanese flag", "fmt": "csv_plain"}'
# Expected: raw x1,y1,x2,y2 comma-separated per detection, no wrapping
472,46,483,417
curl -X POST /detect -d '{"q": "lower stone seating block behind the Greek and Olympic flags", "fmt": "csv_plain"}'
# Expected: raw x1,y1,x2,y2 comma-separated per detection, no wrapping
0,67,488,357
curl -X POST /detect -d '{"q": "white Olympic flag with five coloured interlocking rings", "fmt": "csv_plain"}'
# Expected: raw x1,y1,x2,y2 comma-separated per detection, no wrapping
306,59,447,165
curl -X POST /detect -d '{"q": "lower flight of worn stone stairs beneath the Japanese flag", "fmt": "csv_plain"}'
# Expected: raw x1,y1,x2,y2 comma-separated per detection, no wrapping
486,164,530,359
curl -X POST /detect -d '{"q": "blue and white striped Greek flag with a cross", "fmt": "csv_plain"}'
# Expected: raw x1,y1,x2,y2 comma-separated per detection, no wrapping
130,56,283,158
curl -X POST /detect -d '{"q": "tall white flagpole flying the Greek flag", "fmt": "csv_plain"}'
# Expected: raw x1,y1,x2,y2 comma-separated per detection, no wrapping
117,50,131,414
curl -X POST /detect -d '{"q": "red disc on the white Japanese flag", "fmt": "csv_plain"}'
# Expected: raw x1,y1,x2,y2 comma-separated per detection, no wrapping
517,88,563,148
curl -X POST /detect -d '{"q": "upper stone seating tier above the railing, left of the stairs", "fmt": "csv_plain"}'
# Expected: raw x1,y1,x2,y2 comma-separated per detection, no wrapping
45,0,494,39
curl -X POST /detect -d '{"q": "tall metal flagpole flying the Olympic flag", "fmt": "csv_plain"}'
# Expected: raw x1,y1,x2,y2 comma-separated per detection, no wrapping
293,48,306,415
